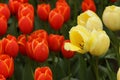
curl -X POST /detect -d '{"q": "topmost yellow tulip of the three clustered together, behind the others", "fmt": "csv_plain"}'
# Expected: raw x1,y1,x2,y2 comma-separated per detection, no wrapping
77,10,103,31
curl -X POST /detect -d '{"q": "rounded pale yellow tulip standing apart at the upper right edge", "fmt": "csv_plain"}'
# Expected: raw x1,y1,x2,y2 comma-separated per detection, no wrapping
102,5,120,31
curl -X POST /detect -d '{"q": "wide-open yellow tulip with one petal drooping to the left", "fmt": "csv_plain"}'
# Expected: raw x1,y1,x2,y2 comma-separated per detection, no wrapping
64,25,90,53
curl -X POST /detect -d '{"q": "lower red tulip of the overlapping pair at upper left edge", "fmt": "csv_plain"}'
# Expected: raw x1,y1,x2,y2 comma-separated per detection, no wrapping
0,14,7,36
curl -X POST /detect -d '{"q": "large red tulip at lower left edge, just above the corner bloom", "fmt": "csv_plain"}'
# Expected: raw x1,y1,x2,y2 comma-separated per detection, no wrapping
0,54,14,78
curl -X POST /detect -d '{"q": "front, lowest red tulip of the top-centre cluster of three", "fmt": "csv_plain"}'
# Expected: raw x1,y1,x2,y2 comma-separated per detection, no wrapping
49,8,64,30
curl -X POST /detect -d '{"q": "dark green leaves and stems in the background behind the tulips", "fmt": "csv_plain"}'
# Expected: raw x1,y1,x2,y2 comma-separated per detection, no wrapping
0,0,120,80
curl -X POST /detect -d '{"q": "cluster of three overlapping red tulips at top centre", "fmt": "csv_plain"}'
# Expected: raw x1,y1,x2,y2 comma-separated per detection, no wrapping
37,0,70,30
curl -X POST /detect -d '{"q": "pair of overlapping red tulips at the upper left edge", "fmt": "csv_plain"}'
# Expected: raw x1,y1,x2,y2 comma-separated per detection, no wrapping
0,3,10,36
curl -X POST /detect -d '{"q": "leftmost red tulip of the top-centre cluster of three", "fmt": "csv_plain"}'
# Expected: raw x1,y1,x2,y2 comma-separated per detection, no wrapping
37,4,51,21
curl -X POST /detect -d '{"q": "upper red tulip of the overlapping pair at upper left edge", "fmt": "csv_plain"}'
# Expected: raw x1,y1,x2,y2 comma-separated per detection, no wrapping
0,3,10,20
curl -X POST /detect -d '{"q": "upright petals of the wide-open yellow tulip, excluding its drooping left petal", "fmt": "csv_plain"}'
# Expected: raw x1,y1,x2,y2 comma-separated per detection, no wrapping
69,25,90,53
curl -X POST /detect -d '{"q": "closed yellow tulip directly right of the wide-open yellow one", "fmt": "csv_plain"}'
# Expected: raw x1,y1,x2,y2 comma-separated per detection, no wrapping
88,30,110,56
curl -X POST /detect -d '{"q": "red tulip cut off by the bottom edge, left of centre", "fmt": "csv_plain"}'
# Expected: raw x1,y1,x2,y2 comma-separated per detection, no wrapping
34,67,53,80
